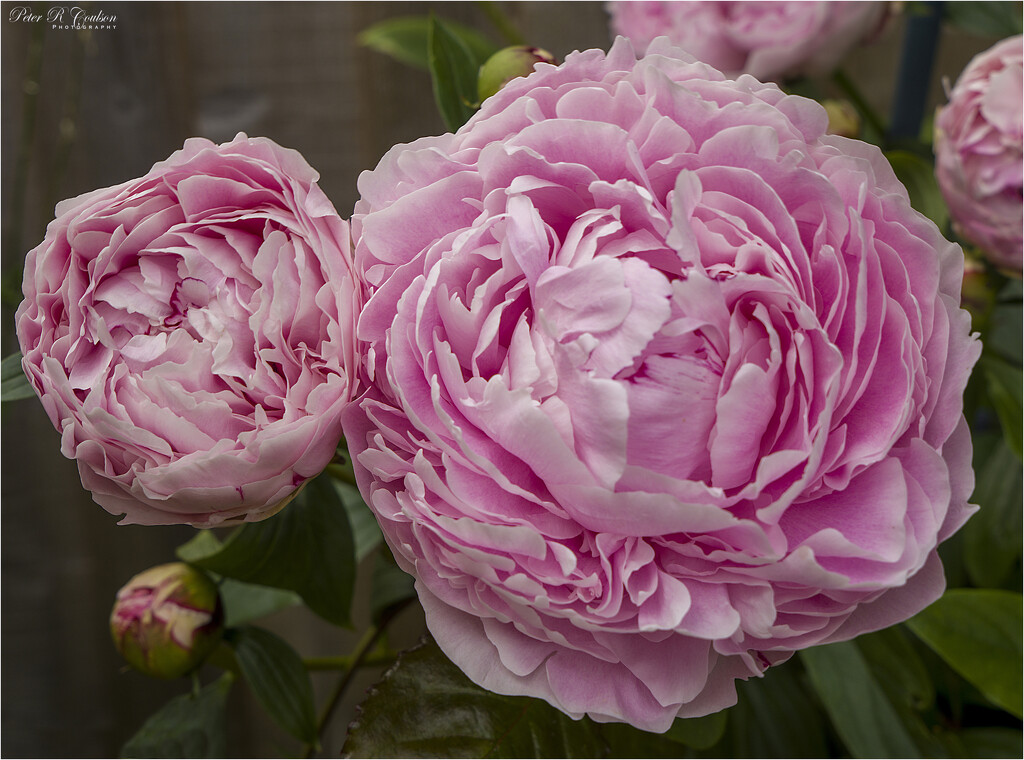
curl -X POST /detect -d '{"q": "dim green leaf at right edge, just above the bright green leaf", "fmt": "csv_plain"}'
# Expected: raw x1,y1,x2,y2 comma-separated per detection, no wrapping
962,437,1024,588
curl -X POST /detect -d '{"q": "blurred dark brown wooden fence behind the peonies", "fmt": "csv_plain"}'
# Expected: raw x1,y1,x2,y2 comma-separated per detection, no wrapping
0,2,1007,757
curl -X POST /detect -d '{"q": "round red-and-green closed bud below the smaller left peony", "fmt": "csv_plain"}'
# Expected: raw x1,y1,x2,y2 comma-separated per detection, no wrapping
111,562,224,678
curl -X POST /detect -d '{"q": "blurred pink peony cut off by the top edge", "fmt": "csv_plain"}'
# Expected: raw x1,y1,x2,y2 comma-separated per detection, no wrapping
607,0,886,80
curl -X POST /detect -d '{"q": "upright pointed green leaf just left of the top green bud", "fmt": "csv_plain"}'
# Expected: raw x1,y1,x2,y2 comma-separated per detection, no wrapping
427,15,480,132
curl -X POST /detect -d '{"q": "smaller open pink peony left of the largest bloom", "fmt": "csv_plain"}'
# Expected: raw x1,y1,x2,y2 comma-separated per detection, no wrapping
16,134,359,526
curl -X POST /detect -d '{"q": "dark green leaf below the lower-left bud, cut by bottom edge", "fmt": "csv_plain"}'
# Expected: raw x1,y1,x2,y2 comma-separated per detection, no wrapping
121,673,234,757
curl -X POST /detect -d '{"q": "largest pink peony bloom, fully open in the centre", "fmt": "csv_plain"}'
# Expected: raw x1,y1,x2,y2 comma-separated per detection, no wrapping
344,39,980,730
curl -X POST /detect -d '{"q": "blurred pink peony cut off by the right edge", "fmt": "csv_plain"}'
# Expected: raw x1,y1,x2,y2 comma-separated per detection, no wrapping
935,36,1024,272
